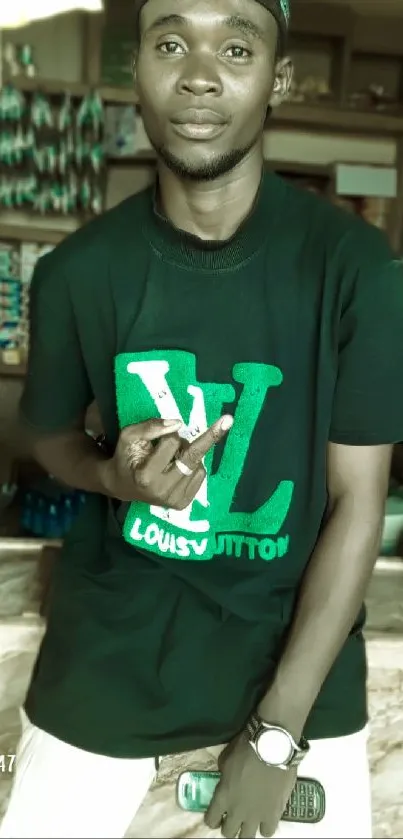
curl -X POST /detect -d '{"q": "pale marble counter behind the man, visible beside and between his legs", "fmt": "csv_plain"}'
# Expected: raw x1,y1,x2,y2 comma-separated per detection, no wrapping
0,546,403,839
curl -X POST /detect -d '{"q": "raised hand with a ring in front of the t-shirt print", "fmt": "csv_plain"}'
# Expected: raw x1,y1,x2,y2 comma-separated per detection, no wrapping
103,414,233,510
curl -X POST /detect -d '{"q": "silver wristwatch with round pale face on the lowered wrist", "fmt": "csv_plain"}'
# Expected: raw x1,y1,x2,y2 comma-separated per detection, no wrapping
246,714,309,769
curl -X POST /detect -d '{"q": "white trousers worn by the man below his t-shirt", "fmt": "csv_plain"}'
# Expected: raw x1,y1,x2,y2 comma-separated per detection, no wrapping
0,714,371,839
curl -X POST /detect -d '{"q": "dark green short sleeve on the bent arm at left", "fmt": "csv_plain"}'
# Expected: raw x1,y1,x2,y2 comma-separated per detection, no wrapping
20,252,92,433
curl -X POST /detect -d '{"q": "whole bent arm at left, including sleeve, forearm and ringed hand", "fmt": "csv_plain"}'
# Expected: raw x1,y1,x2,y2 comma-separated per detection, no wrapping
20,254,232,510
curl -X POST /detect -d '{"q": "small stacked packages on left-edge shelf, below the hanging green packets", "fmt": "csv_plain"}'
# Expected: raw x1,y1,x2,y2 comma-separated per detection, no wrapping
0,242,53,365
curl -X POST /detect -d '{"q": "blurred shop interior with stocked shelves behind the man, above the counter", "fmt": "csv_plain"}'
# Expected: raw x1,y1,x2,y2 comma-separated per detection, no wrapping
0,0,403,555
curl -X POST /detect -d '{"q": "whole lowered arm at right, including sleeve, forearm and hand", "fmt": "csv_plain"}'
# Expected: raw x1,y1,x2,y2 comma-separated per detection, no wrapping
206,230,403,839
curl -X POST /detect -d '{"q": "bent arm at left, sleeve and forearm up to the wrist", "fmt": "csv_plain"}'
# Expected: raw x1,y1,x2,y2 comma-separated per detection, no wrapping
20,253,108,494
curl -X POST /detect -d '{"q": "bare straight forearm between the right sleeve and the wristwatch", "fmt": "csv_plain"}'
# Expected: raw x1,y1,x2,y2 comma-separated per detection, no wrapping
258,443,392,740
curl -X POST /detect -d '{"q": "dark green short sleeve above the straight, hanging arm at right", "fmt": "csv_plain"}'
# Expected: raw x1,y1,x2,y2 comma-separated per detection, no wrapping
329,230,403,446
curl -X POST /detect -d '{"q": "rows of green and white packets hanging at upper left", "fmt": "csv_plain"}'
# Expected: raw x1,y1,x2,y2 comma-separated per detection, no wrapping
0,85,104,216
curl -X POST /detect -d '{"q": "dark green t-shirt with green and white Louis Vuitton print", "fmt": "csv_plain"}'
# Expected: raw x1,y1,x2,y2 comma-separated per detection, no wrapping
22,175,403,757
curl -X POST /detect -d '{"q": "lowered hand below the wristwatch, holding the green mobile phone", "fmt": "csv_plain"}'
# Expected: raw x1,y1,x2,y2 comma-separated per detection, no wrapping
205,733,297,839
